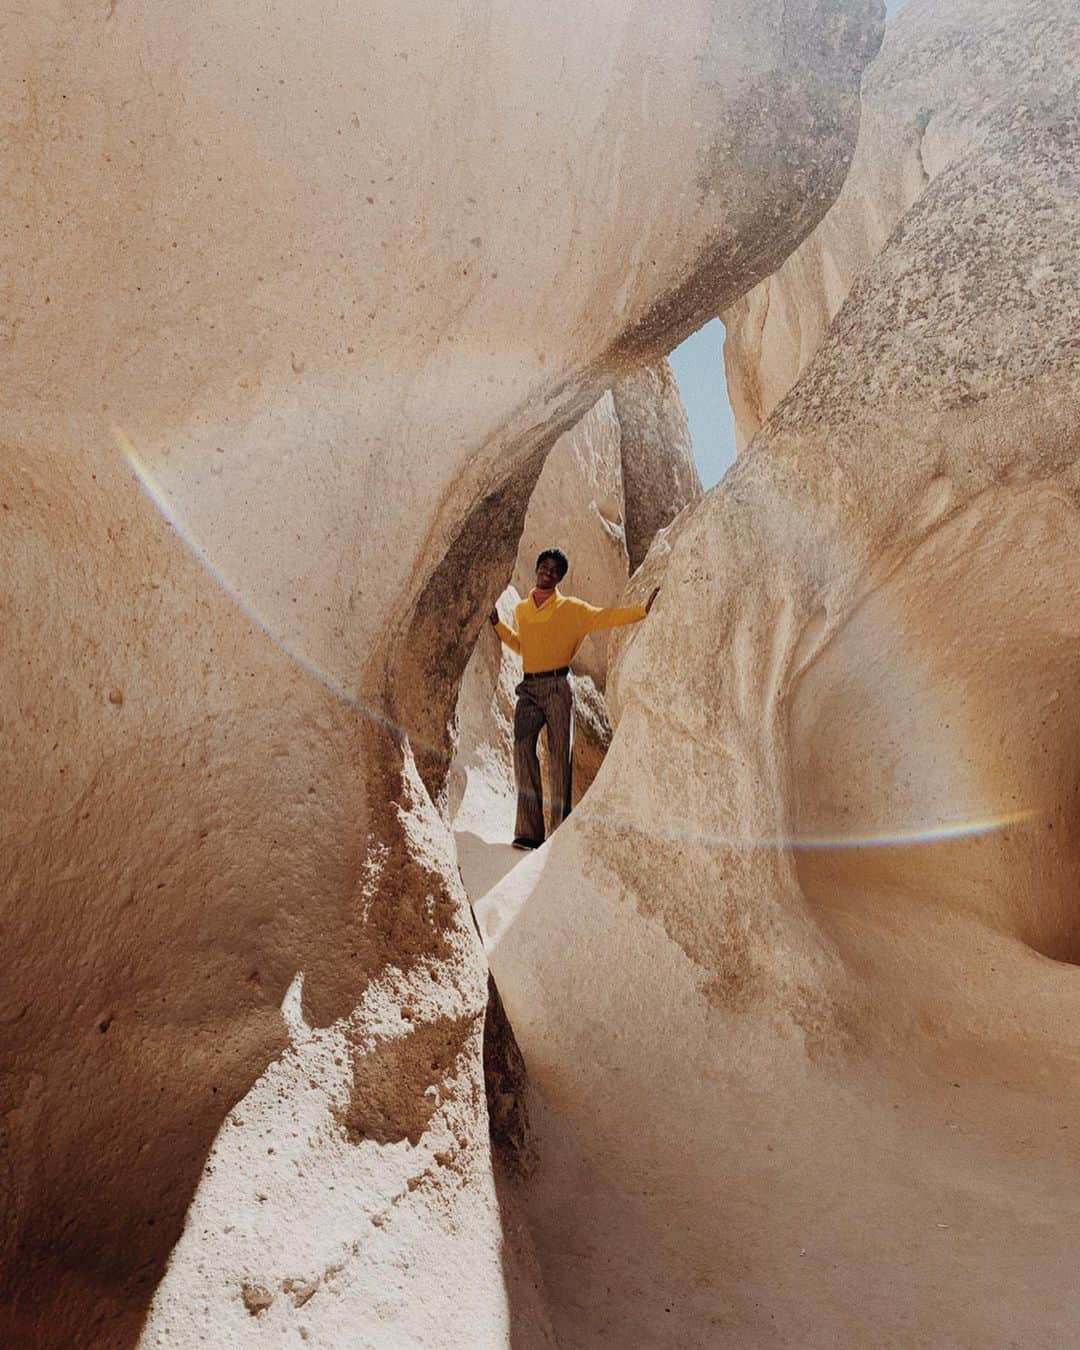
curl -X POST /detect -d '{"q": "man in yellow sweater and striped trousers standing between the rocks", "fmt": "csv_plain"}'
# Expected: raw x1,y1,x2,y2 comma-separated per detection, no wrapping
490,548,660,849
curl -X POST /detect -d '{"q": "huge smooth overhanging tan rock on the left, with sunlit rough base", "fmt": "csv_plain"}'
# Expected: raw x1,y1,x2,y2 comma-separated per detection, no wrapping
0,0,880,1350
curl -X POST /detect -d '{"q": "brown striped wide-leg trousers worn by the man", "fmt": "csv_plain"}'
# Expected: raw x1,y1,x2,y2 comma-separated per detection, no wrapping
514,675,574,844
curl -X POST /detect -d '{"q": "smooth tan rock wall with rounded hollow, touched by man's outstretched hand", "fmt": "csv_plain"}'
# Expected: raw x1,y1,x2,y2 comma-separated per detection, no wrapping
481,0,1080,1350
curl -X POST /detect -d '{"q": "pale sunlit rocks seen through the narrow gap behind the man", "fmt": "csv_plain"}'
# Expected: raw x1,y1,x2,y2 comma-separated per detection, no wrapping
441,360,702,905
